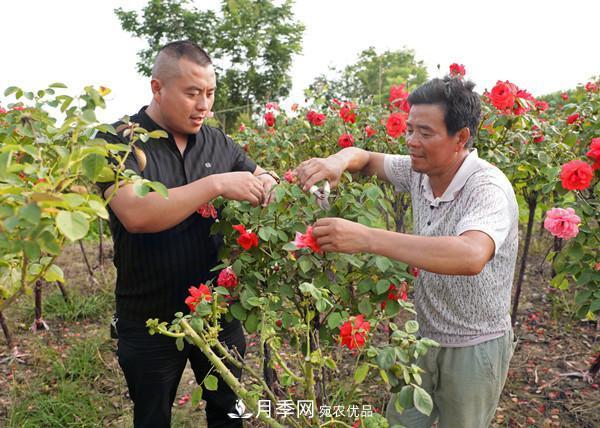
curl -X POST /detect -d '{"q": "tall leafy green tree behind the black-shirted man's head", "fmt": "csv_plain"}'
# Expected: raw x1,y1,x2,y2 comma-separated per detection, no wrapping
115,0,304,129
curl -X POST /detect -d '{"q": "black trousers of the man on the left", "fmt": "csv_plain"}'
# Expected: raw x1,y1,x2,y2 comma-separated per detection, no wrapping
116,319,246,428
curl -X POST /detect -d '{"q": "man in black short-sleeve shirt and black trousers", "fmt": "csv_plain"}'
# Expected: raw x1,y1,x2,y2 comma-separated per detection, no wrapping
101,41,276,428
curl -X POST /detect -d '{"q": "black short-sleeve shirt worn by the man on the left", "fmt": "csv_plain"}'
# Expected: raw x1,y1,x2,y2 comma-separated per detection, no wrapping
98,107,256,321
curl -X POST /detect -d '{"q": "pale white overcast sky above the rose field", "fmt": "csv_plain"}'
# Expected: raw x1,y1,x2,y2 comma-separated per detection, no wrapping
0,0,600,121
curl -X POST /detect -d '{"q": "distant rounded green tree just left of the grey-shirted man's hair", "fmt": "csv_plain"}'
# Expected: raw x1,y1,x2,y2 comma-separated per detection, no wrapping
310,47,427,104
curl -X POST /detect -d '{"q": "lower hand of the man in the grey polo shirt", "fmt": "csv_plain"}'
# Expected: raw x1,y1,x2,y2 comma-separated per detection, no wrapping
313,218,370,254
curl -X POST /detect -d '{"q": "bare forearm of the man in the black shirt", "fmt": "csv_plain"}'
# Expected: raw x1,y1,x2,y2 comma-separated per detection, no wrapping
107,175,221,233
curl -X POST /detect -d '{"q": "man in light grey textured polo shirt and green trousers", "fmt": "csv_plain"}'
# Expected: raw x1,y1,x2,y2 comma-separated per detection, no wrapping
296,77,518,428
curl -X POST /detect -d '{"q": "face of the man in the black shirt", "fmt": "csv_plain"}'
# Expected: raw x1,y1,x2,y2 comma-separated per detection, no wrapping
155,59,216,136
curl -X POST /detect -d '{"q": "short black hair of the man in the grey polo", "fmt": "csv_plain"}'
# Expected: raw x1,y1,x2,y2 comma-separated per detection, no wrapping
408,76,481,147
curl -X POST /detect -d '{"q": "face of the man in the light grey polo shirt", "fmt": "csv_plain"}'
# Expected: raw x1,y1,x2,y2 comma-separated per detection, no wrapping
406,104,463,176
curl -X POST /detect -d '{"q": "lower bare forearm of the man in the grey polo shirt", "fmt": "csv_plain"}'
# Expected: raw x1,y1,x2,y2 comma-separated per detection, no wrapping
364,228,493,275
